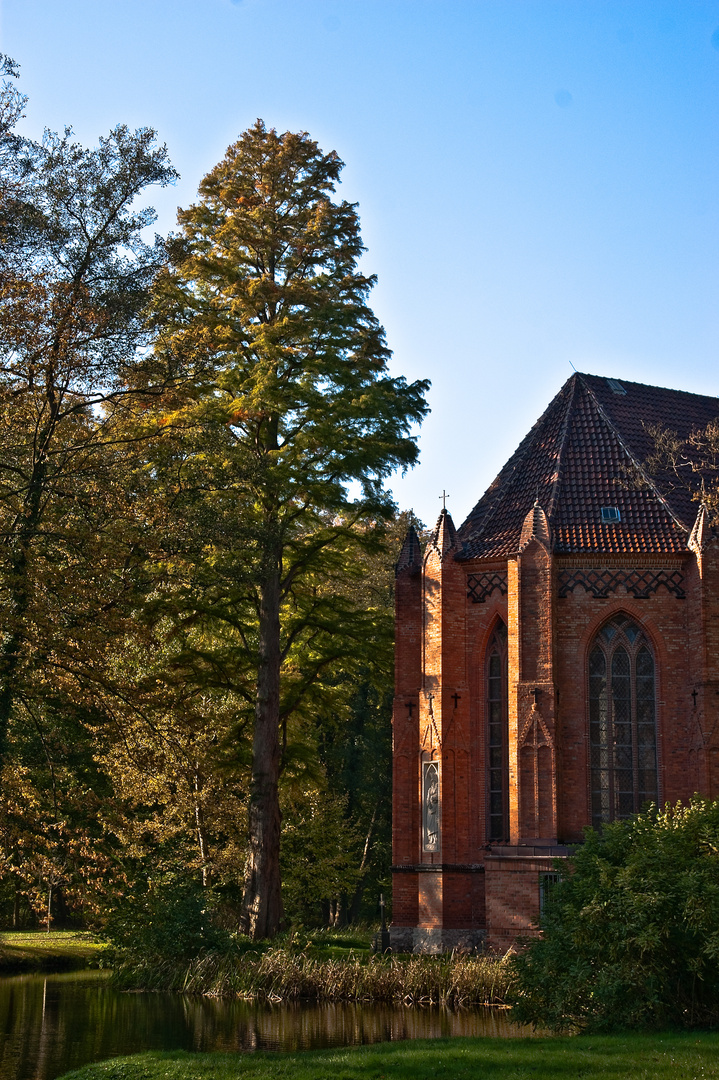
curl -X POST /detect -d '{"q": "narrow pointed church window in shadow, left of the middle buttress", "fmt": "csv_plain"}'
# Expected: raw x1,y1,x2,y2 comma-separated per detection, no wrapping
486,620,510,840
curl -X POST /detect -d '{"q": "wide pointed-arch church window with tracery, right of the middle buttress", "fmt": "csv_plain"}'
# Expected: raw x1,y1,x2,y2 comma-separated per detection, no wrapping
589,615,659,827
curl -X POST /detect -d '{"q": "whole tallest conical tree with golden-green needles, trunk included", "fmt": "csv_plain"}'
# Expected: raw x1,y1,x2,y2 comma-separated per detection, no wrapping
146,121,428,937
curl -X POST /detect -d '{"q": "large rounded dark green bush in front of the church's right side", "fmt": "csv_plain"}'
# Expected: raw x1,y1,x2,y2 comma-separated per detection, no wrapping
513,797,719,1031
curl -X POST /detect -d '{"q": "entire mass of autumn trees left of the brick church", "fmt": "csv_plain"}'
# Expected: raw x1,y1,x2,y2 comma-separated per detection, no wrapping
0,57,428,937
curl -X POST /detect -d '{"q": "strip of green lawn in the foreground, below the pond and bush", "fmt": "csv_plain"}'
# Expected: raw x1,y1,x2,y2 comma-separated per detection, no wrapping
58,1032,719,1080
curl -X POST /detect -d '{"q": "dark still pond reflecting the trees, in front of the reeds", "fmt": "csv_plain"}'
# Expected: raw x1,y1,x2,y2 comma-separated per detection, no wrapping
0,971,531,1080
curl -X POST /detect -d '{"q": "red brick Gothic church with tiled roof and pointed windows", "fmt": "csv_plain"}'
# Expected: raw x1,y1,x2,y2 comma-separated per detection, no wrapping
391,374,719,951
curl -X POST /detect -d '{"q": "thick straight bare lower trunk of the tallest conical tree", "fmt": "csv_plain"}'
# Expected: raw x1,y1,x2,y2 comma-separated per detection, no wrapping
243,564,282,941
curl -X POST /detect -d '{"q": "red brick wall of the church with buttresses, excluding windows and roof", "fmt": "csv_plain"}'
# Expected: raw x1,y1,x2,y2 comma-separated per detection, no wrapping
394,540,719,947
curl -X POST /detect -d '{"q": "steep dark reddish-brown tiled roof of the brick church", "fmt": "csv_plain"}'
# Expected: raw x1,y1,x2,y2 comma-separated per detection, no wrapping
459,374,719,558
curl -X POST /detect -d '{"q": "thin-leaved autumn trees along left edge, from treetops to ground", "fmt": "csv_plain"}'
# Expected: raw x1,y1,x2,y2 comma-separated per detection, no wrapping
0,58,176,926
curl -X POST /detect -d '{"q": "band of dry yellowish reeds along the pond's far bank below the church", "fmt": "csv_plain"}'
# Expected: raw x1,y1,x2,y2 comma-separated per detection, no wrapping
113,948,513,1008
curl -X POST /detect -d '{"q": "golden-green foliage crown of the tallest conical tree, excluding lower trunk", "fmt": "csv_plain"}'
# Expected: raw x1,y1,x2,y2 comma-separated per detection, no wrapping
136,121,428,734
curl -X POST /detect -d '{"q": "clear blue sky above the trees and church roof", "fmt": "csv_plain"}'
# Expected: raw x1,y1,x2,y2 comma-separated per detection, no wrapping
0,0,719,524
